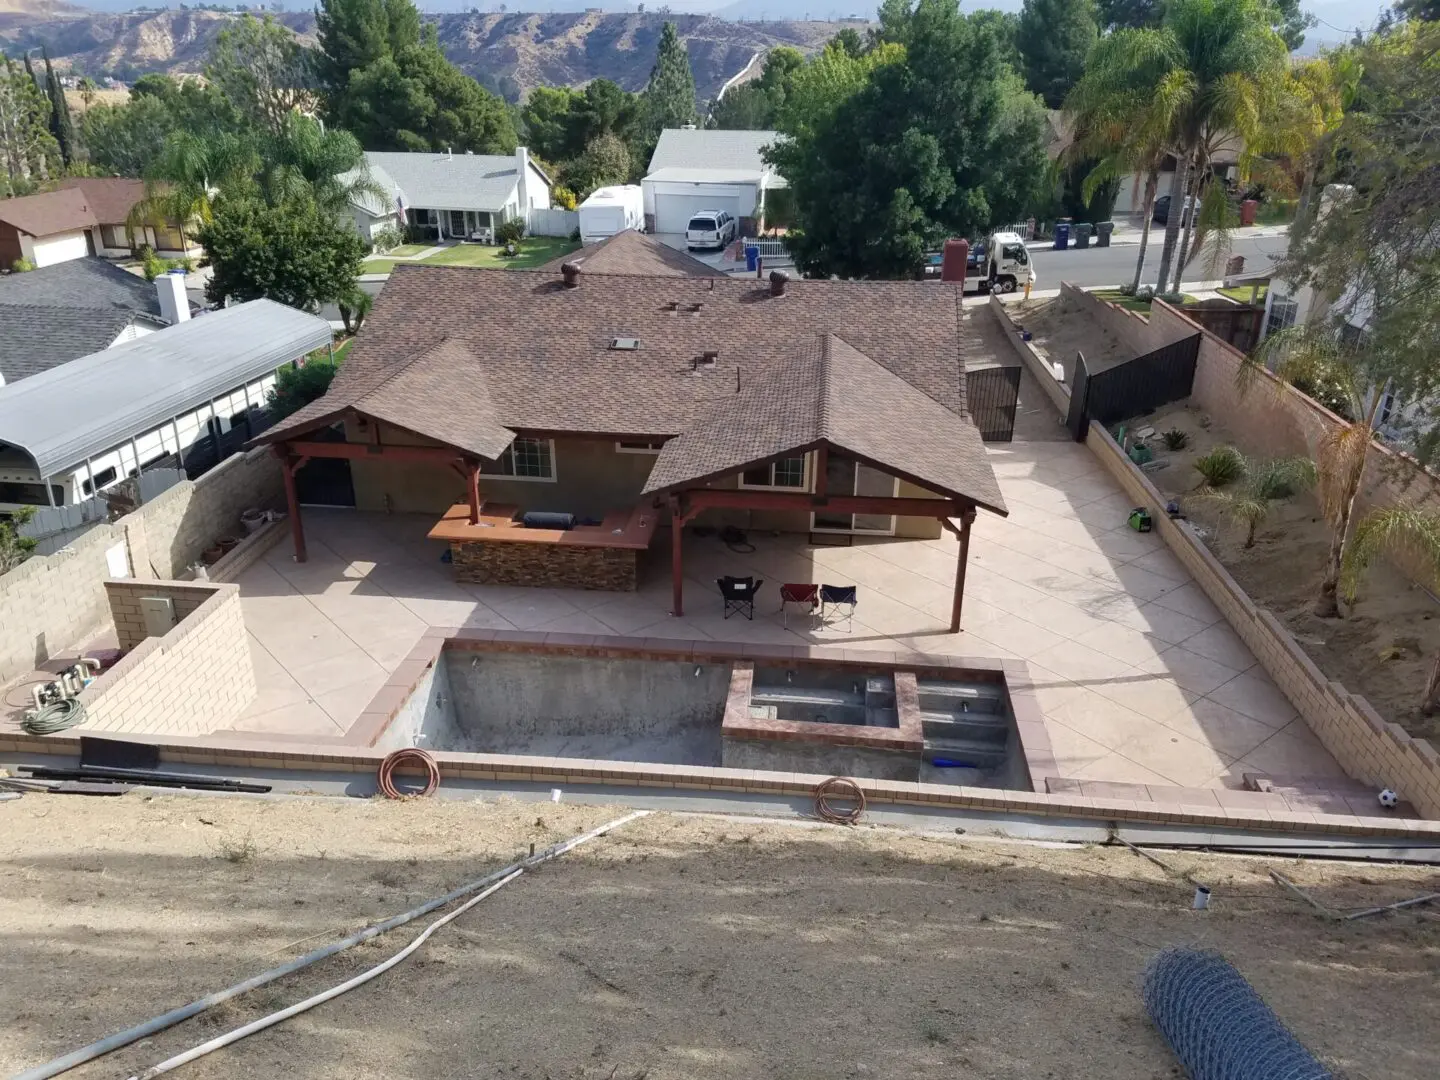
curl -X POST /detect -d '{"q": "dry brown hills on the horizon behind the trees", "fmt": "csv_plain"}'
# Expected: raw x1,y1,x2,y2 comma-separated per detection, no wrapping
0,9,841,98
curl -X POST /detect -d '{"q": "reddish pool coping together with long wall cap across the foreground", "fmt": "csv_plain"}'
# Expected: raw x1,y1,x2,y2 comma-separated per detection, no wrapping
0,628,1440,842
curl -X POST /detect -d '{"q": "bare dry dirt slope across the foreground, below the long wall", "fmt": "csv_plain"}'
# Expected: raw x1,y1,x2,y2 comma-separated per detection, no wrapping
0,795,1440,1080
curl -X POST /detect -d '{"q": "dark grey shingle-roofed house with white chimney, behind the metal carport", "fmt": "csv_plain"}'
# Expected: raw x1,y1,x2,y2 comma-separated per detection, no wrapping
0,256,190,384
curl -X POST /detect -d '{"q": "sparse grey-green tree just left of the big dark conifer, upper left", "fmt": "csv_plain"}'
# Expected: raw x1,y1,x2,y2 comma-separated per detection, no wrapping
204,14,314,131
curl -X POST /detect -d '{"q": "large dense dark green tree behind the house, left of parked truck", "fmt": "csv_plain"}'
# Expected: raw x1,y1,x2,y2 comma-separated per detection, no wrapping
768,0,1045,278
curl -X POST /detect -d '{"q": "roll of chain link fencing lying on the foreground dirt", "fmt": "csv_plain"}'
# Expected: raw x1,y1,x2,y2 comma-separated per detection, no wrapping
1142,949,1335,1080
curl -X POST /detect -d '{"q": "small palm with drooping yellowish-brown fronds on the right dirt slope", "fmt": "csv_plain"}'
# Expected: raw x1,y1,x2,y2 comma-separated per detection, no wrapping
1238,323,1387,619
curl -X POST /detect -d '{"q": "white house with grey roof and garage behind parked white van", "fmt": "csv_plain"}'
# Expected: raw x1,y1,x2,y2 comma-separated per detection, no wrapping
641,128,786,236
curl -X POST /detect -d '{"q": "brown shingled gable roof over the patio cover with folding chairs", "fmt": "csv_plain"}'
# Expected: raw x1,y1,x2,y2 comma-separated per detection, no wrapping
645,334,1005,513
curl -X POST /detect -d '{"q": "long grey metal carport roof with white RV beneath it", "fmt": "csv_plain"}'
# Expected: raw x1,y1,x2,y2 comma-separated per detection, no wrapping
0,293,331,518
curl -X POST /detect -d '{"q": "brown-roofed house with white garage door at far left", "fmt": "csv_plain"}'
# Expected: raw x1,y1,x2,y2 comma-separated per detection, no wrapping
0,176,203,269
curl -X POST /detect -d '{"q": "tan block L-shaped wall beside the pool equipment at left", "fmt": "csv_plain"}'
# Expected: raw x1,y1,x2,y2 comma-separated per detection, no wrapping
76,580,255,736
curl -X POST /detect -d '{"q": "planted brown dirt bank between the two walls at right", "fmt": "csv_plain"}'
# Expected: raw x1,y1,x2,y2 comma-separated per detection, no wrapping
1126,406,1440,739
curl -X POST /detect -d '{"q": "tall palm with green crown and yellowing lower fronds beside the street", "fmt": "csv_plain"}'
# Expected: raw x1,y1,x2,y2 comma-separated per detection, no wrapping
1086,0,1287,291
